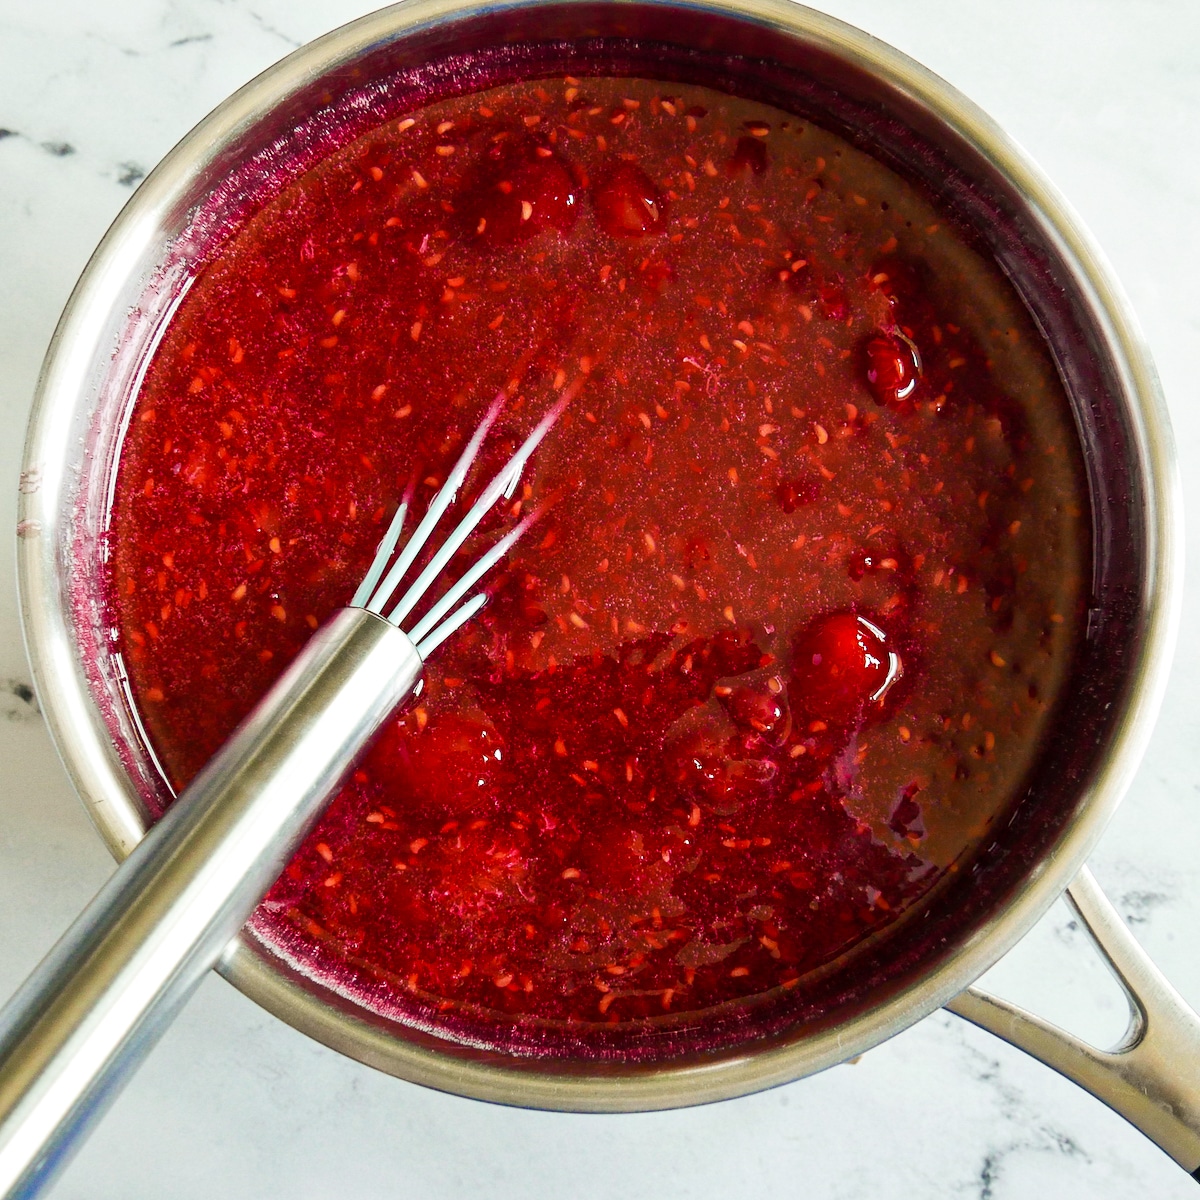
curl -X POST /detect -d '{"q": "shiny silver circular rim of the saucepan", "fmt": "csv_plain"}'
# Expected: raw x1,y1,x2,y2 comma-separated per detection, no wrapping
18,0,1182,1111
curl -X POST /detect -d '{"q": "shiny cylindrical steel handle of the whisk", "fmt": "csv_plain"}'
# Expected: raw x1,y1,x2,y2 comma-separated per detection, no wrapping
0,608,421,1198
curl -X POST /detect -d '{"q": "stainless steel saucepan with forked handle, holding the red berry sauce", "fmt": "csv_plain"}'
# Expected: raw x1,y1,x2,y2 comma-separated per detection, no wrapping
16,0,1200,1172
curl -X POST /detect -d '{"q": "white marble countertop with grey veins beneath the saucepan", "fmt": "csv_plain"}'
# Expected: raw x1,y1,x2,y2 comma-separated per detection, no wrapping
0,0,1200,1200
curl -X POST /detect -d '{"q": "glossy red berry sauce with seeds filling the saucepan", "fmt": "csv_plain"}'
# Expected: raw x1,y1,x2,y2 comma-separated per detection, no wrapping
109,78,1087,1044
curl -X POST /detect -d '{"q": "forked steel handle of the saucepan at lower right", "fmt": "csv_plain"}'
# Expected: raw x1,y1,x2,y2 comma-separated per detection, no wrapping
946,866,1200,1182
